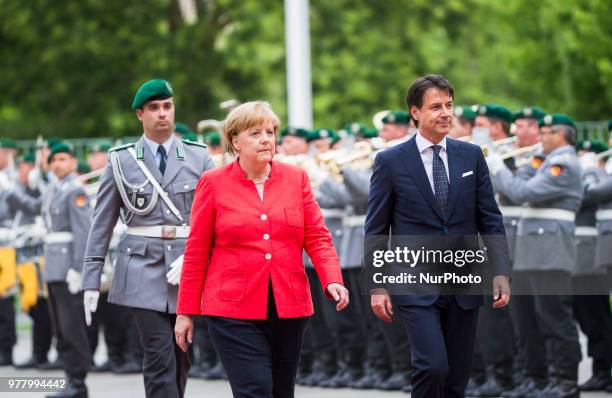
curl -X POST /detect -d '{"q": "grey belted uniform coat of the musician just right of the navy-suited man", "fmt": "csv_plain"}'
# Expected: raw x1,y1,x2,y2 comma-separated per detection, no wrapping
492,145,582,271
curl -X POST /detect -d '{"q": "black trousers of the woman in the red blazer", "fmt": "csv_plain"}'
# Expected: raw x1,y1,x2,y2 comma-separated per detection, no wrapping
206,286,308,398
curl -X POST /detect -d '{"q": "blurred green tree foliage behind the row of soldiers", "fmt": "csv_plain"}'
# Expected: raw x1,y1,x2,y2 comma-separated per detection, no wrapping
0,0,612,138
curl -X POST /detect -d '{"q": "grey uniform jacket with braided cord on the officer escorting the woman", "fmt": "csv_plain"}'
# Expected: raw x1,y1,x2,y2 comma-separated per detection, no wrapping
83,137,214,313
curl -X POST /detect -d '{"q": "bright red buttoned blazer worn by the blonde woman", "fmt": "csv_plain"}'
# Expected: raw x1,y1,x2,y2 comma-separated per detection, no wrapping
176,161,343,319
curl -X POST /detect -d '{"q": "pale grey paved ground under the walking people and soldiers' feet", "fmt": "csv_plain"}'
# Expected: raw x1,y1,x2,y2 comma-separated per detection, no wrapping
0,316,612,398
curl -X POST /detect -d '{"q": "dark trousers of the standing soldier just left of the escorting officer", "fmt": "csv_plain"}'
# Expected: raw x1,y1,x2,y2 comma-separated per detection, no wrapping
47,282,91,384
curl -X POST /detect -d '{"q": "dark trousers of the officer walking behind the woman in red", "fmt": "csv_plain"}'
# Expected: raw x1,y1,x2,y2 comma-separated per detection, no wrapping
131,308,190,398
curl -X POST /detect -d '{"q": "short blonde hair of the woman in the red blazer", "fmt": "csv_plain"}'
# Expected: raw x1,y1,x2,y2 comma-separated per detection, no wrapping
223,101,280,155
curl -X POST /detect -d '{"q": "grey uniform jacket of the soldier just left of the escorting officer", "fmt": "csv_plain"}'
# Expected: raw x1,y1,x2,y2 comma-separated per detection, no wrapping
7,174,91,282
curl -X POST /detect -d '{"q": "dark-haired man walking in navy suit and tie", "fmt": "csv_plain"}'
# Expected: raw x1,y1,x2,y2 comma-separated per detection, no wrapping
365,75,510,398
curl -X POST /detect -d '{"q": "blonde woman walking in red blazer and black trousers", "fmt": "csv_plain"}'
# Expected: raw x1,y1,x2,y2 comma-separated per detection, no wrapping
175,101,349,398
